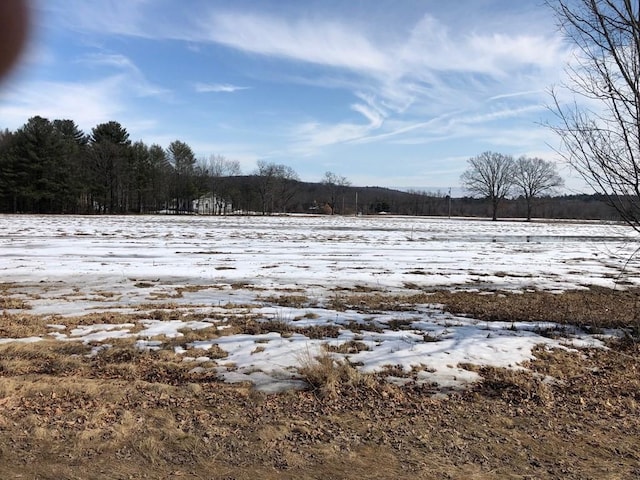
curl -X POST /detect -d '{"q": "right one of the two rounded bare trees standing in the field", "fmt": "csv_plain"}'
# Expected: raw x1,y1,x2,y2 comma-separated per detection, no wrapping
513,156,564,222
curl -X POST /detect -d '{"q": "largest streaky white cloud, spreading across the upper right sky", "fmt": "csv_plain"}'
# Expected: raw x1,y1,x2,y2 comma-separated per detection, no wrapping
185,6,567,152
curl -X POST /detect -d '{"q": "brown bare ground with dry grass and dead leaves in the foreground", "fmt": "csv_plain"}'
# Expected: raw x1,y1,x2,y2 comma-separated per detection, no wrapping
0,289,640,479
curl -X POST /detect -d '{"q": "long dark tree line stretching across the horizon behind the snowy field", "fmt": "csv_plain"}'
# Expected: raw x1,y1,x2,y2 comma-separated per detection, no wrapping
0,117,619,220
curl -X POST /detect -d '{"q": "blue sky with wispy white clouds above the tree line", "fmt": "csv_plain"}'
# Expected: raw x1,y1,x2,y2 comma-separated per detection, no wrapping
0,0,580,192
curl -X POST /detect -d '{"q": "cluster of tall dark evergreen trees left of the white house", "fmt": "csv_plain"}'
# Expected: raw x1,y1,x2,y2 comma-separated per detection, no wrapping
0,116,178,213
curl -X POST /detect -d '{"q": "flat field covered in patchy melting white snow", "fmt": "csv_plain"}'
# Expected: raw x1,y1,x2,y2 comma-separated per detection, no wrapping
0,216,640,390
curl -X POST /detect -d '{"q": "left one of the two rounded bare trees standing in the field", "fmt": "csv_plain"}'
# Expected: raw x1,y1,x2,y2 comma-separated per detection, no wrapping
460,152,514,221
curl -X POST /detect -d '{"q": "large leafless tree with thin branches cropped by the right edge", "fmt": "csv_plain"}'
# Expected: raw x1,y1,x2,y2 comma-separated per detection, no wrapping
547,0,640,231
